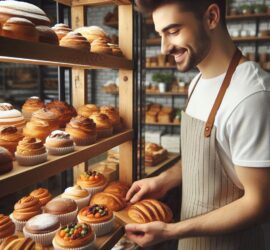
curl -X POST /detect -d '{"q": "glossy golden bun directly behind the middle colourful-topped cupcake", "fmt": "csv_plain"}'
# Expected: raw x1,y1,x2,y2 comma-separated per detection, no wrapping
90,192,127,211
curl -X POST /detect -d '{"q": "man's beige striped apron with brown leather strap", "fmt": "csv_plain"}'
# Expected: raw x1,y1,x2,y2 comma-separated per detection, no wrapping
178,51,264,250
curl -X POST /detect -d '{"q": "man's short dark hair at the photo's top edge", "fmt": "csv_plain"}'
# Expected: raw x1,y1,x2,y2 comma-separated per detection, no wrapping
135,0,226,26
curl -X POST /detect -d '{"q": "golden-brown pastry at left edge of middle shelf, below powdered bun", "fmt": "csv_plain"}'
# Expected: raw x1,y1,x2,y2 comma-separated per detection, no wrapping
0,126,23,156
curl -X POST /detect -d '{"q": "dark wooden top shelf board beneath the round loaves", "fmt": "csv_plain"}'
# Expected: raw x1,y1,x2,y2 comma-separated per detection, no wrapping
0,37,133,69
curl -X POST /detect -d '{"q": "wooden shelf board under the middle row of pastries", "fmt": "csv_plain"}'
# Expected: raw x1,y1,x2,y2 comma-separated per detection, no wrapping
0,129,133,197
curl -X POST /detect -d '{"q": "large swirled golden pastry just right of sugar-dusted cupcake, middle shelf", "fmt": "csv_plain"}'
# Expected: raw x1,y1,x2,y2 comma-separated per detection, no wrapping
66,115,97,146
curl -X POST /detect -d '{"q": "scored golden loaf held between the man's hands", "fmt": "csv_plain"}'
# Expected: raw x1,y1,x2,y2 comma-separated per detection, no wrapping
128,199,173,223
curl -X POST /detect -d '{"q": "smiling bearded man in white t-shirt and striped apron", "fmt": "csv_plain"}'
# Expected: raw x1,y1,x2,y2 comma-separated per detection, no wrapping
126,0,270,250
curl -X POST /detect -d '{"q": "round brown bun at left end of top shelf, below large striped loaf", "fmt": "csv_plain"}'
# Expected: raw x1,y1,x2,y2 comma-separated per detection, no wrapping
1,17,38,42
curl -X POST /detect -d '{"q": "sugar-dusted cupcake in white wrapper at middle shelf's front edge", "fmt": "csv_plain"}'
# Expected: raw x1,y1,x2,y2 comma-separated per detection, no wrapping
45,130,74,155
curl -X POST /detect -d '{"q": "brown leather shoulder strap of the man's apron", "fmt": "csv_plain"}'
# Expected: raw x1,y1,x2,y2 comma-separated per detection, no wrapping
204,49,242,137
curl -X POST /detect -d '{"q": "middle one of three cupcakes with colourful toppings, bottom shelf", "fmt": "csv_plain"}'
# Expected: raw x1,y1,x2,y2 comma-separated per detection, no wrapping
77,204,114,236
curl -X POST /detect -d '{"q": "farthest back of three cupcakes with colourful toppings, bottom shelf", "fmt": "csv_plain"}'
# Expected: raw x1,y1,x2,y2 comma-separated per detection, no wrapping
77,171,107,195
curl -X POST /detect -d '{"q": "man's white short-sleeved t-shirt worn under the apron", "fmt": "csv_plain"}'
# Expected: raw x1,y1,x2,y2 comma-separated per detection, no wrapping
186,61,270,188
